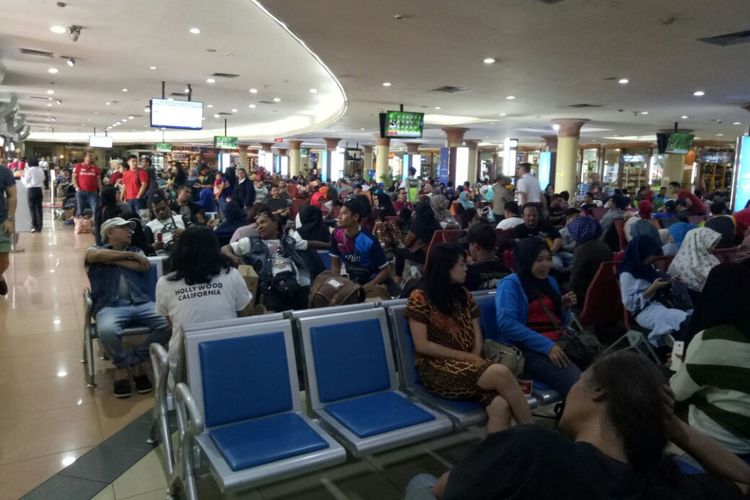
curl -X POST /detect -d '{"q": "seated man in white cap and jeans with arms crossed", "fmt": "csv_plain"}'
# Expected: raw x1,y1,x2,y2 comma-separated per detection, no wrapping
85,217,171,398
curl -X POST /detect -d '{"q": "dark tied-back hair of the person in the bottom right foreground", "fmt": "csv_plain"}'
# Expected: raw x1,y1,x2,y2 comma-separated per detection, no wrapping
589,351,679,498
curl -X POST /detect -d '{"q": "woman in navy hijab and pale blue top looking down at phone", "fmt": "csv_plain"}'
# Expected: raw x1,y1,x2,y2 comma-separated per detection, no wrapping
619,236,688,346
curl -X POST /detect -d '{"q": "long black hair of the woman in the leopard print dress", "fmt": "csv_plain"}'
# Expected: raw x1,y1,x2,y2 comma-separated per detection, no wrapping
422,243,468,314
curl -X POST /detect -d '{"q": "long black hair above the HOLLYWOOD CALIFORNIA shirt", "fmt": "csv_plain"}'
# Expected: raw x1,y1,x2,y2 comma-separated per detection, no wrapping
167,226,230,285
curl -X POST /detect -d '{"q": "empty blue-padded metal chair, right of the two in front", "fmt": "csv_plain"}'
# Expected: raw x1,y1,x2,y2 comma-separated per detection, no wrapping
299,308,453,456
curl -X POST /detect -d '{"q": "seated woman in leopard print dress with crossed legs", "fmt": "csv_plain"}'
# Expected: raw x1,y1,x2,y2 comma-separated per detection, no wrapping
406,244,532,432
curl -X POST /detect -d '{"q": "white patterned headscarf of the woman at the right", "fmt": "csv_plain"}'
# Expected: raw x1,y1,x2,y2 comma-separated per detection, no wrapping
669,227,721,292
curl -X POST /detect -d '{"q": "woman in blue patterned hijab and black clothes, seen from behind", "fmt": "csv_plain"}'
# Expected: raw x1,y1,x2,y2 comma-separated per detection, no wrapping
566,217,612,305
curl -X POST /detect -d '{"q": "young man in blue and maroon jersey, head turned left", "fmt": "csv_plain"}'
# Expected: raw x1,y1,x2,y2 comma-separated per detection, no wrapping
331,199,391,285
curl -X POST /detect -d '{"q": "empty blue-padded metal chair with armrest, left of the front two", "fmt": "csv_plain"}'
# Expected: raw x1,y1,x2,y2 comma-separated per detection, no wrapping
170,320,346,492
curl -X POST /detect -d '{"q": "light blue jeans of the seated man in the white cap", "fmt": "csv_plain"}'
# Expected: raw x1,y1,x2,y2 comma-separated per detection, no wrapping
96,302,172,368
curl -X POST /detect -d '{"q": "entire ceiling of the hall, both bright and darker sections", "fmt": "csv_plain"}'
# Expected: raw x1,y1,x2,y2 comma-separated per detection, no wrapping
0,0,750,145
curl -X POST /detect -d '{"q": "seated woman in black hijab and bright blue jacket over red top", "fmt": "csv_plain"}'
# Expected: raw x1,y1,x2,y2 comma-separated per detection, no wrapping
495,238,581,397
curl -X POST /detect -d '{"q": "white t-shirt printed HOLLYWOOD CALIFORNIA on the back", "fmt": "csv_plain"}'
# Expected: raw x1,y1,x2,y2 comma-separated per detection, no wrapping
156,268,252,370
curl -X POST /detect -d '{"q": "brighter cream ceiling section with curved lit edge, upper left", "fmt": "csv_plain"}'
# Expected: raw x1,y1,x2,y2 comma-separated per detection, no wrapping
0,0,346,142
